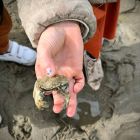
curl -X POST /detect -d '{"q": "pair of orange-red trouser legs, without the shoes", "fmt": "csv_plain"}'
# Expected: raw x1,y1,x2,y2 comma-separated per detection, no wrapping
85,0,120,55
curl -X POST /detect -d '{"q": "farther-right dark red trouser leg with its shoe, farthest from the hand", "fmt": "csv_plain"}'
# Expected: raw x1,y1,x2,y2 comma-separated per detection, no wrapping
102,0,120,51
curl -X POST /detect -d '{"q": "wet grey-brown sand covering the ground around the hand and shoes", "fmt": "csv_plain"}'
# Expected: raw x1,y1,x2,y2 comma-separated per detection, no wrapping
0,0,140,140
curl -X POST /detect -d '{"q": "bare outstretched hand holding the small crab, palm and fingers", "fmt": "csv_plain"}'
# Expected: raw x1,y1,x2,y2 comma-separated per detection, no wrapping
35,22,84,117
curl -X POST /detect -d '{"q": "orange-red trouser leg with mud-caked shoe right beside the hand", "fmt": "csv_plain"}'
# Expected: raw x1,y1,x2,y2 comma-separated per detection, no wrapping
84,4,106,90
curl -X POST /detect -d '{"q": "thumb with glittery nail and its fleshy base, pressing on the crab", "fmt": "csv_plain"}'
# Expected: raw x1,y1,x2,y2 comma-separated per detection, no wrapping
36,26,64,77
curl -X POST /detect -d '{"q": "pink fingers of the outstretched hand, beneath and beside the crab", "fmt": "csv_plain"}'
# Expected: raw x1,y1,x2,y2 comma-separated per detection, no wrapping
53,72,85,117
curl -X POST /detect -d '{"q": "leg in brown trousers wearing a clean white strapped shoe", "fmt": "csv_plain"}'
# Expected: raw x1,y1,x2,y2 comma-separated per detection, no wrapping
0,7,36,66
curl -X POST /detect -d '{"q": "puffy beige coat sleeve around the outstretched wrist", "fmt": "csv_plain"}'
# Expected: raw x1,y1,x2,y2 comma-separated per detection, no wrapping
18,0,96,48
